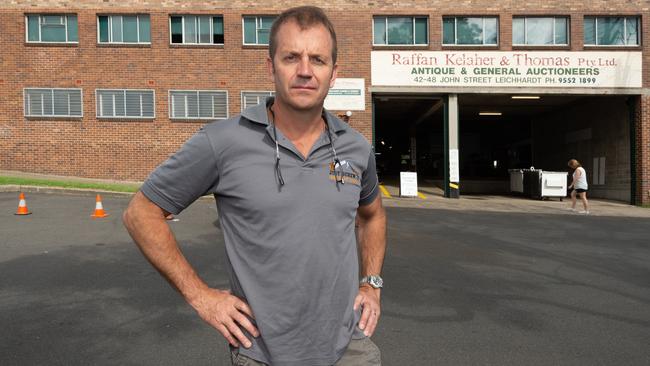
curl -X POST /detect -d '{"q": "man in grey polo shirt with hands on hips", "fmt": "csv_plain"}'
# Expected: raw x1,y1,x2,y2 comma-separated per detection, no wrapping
124,7,386,366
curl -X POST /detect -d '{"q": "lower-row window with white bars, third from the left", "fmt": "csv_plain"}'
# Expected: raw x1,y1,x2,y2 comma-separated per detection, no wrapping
169,90,228,119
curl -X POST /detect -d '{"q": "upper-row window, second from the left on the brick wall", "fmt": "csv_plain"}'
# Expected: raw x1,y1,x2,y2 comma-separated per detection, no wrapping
97,14,151,43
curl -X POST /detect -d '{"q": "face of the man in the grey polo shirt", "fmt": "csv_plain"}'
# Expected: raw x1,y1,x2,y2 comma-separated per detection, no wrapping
267,21,337,111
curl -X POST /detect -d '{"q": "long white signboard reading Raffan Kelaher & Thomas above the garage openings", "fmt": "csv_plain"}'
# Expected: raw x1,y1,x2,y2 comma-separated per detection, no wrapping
371,51,641,88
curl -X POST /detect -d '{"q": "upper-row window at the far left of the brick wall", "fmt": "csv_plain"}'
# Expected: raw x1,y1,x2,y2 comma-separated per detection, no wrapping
25,14,79,43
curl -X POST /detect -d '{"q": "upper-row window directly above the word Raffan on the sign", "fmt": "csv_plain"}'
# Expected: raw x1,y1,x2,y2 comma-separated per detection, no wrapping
372,17,429,46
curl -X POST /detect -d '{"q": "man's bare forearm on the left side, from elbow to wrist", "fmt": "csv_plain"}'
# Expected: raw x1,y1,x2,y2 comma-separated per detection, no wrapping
123,192,208,303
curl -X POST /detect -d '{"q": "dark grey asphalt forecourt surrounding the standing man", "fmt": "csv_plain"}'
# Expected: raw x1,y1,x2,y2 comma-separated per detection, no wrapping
0,192,650,366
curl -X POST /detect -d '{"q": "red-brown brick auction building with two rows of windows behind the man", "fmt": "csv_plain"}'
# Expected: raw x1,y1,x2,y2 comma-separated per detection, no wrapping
0,0,650,204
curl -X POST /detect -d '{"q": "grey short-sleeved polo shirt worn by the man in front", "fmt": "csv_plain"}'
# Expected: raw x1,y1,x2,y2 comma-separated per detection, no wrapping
141,98,378,366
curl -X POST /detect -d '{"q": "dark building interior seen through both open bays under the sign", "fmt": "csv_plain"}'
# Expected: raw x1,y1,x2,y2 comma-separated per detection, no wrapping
373,94,631,201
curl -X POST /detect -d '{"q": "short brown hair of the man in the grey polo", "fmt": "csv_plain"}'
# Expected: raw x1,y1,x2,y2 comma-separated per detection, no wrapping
269,6,337,64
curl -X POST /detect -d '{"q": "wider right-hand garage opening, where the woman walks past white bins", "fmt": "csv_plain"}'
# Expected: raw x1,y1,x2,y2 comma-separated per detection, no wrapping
458,94,632,202
